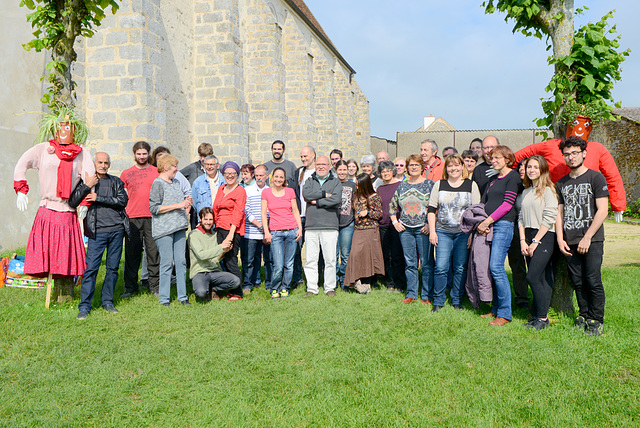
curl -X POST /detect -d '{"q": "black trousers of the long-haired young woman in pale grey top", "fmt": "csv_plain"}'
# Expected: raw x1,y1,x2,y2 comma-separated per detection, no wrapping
524,228,556,318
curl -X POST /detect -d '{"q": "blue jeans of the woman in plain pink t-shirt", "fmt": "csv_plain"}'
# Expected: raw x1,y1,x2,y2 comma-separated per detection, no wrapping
271,228,298,292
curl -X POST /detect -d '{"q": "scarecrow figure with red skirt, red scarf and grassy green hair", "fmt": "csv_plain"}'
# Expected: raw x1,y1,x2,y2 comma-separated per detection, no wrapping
13,107,97,294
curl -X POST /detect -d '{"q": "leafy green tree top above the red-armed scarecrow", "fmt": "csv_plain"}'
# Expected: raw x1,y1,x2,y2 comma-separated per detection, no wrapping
483,0,630,138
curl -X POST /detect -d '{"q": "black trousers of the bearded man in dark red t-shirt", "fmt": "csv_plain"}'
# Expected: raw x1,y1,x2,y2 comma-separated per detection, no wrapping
124,217,160,293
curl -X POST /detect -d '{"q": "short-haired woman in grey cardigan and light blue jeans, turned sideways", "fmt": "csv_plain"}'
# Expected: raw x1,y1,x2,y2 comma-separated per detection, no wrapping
149,154,193,306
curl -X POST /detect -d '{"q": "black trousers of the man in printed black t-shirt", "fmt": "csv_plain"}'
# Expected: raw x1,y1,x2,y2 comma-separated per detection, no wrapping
567,242,604,322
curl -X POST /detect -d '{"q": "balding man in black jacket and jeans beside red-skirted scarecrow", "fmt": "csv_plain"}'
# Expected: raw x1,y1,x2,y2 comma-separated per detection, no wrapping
69,152,129,320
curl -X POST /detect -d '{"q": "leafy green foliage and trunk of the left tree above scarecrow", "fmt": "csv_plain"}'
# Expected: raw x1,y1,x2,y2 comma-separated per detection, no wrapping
20,0,119,112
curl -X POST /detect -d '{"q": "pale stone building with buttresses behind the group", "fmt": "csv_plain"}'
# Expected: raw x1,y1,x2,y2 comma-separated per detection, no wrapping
0,0,371,249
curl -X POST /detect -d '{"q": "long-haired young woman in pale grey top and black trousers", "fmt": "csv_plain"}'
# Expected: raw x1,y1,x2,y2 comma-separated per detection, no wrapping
518,155,558,330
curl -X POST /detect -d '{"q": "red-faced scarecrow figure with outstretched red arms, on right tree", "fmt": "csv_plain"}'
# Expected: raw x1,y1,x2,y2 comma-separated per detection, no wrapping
515,116,627,222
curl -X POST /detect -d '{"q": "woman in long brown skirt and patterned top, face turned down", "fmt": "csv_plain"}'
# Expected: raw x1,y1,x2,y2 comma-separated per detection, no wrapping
344,173,384,294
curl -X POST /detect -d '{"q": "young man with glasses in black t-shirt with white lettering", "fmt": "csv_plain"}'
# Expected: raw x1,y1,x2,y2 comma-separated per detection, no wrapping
556,137,609,336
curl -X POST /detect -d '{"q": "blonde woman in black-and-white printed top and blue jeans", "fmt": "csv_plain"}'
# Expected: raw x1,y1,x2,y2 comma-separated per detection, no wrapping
428,153,480,312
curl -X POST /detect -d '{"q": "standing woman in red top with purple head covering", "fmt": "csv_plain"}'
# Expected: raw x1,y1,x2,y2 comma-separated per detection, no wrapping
213,161,247,290
